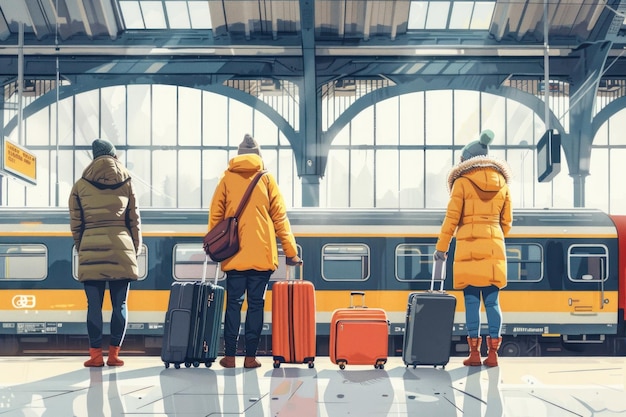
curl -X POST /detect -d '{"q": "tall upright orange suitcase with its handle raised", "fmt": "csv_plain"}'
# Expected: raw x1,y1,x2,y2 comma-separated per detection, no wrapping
272,266,316,368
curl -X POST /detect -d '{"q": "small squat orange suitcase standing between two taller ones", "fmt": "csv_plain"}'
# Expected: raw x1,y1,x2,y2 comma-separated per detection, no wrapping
328,291,389,369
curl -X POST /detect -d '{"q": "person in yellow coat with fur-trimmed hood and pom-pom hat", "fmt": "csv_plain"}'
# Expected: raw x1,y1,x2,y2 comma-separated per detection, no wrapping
434,130,513,366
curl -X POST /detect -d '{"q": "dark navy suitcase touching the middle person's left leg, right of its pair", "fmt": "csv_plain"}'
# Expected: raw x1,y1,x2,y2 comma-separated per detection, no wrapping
185,255,224,367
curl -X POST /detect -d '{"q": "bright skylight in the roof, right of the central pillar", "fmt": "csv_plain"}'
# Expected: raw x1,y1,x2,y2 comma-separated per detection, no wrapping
408,1,496,30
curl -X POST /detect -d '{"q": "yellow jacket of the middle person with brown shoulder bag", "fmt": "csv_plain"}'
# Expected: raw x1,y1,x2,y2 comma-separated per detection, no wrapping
209,154,298,271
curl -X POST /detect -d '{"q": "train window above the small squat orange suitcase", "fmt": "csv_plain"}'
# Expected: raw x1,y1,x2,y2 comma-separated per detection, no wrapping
322,243,370,281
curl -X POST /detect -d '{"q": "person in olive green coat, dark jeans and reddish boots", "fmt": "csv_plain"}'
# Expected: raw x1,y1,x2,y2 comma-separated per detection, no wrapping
68,139,141,367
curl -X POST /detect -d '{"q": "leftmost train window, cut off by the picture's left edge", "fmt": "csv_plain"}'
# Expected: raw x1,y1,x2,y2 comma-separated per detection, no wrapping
0,244,48,281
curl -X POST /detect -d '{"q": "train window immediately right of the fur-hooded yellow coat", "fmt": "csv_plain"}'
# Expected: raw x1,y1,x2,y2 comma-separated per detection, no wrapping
506,243,543,282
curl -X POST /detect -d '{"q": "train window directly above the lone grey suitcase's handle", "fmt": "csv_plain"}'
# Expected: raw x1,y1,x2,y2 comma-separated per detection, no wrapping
396,243,435,281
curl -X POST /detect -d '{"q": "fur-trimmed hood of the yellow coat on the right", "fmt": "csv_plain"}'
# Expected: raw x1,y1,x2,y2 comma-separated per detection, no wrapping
448,155,511,191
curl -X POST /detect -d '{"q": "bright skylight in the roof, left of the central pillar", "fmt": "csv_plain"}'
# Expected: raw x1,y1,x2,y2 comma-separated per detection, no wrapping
118,0,211,29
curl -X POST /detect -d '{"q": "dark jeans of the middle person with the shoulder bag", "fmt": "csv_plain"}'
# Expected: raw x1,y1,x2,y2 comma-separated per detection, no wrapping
224,271,271,356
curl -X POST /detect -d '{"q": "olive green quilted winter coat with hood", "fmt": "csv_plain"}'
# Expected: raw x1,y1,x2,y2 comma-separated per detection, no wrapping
69,155,141,282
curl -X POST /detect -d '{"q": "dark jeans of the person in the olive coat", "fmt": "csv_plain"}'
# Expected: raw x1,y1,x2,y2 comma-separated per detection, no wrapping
83,279,130,348
